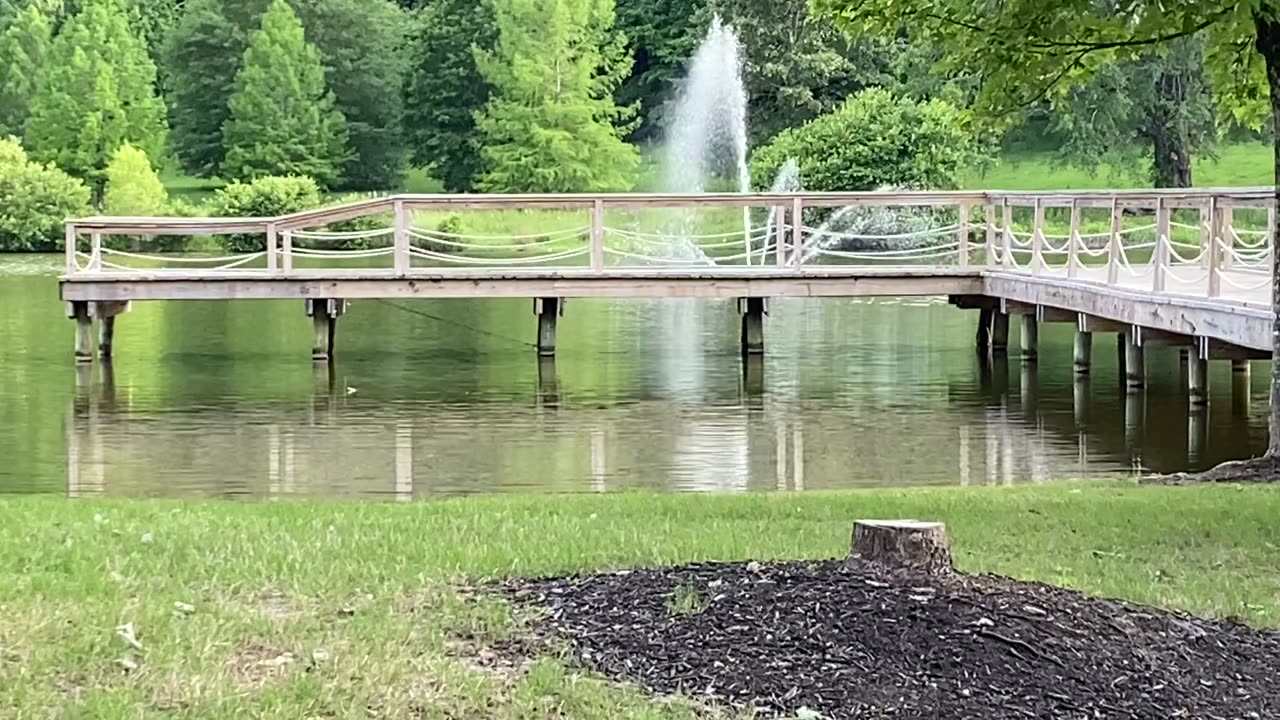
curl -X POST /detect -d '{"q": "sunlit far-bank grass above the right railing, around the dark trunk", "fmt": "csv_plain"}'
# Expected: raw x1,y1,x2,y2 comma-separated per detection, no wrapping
961,142,1275,190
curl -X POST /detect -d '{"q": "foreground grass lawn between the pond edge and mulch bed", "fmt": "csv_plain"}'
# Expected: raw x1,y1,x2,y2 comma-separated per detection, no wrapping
0,484,1280,719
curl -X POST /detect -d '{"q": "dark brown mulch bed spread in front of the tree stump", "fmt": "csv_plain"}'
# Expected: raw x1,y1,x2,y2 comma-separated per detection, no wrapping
504,561,1280,720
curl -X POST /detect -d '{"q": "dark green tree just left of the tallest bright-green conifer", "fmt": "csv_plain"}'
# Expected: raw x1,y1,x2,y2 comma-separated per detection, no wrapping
403,0,498,192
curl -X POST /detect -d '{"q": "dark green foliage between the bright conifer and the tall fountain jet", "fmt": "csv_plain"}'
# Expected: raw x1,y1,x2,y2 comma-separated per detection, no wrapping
616,0,710,141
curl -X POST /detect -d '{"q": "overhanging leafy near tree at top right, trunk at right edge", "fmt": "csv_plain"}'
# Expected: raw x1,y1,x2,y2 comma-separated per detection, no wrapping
814,0,1280,458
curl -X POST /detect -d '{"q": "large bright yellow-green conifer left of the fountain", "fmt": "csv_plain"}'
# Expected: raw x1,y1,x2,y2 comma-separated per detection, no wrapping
476,0,639,192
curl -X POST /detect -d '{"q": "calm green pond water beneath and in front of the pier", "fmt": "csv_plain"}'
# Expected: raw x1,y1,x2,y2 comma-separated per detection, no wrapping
0,258,1266,500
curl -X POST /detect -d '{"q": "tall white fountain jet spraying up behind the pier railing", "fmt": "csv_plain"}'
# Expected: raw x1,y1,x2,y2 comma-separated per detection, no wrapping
663,15,751,261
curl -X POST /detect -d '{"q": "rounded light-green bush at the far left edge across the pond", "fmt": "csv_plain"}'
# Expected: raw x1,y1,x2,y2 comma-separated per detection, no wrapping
0,137,88,252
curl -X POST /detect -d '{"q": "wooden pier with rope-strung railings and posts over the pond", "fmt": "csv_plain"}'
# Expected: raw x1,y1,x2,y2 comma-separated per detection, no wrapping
60,188,1276,386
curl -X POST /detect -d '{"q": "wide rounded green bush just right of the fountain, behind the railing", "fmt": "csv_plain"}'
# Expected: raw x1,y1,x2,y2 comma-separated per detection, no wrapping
751,88,979,191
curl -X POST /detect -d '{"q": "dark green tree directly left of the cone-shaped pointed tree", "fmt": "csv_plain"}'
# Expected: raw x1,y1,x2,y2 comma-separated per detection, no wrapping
165,0,261,176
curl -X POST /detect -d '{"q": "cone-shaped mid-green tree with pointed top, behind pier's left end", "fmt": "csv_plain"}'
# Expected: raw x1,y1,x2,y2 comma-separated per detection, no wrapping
223,0,351,186
